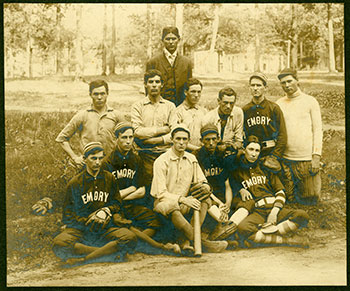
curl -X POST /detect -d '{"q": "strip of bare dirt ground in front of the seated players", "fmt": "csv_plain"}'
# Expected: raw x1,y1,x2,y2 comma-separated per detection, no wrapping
7,231,346,286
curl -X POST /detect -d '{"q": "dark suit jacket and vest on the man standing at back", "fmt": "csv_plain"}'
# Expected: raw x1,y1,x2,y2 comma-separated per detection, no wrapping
146,52,192,106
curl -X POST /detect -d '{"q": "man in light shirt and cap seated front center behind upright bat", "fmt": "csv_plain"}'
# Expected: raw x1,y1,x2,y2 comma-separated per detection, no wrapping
151,124,228,252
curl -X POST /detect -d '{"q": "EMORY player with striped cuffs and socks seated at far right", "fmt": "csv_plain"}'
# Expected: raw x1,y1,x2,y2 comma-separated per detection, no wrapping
233,135,309,247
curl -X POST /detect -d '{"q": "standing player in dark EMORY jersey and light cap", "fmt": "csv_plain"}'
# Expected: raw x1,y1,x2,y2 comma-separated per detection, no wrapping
243,72,287,172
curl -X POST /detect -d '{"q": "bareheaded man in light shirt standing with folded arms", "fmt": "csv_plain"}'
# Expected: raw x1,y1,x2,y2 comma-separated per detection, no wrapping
131,70,176,185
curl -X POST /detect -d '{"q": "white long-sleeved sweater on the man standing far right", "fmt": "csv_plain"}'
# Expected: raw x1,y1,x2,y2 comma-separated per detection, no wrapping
276,89,323,161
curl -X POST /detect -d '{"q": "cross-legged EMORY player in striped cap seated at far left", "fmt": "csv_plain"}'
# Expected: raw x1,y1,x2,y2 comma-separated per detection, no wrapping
53,142,136,265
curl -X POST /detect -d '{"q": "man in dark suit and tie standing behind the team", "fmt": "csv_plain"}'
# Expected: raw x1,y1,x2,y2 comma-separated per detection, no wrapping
146,26,192,106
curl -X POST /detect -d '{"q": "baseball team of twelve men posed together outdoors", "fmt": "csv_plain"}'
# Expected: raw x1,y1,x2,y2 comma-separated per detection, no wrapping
34,27,322,264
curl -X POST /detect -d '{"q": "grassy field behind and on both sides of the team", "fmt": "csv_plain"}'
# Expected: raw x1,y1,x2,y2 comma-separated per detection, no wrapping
5,77,346,272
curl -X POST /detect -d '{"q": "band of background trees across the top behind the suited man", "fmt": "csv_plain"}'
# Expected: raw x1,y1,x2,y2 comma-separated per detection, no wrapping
4,3,344,78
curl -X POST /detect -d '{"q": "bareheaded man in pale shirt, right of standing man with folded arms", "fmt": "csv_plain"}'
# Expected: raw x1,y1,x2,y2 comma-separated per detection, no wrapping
175,78,207,151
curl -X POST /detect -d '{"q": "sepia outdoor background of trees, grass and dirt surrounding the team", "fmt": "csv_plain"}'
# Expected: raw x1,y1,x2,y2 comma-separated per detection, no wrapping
3,3,346,286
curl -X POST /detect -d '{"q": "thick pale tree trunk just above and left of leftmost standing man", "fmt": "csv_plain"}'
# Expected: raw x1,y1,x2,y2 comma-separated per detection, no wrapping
74,4,84,81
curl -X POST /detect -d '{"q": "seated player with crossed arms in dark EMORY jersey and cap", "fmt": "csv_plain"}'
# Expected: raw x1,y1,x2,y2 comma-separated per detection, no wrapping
107,122,160,241
